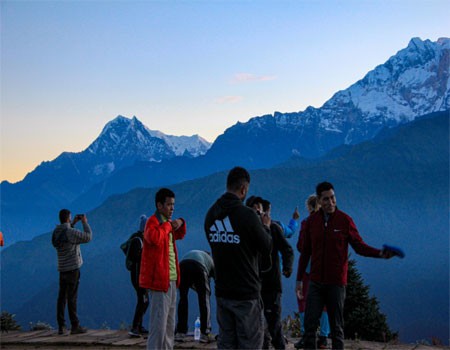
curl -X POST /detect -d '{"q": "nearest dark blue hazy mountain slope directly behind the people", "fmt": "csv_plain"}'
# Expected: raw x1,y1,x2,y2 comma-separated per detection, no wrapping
1,110,450,342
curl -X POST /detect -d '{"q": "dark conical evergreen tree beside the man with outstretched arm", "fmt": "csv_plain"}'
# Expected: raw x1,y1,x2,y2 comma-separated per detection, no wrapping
344,259,397,342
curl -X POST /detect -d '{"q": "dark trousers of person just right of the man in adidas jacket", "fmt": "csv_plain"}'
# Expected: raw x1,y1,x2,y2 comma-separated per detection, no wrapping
261,292,286,349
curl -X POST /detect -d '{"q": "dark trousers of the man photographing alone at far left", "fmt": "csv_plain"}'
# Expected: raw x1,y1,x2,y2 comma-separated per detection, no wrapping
56,269,80,329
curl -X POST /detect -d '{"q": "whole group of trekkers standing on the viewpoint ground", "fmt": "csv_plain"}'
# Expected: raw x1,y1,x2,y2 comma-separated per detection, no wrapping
52,167,394,349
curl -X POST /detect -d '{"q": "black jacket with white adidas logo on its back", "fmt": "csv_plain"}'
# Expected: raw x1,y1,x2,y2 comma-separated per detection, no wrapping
204,192,272,300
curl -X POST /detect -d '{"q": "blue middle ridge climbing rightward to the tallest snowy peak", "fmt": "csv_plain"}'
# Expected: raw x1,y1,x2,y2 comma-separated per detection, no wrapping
65,39,450,226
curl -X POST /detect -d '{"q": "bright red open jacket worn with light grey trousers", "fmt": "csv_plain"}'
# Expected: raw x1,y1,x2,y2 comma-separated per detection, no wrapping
139,213,186,292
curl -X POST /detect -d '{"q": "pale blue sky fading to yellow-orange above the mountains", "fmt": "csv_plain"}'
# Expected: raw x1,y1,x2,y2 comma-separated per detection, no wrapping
0,0,450,182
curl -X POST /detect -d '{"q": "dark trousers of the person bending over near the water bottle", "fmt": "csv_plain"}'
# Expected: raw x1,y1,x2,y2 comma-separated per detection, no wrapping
176,260,211,334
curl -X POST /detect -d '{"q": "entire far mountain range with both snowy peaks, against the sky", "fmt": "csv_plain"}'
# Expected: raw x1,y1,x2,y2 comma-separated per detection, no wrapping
0,38,450,243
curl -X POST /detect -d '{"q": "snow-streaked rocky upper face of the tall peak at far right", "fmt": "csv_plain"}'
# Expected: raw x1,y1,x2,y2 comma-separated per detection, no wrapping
321,38,450,129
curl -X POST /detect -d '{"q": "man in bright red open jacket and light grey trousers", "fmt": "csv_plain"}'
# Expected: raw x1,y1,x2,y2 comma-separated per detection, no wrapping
139,188,186,349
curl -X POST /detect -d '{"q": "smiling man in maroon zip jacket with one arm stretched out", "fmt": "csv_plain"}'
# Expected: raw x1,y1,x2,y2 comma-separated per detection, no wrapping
297,182,393,349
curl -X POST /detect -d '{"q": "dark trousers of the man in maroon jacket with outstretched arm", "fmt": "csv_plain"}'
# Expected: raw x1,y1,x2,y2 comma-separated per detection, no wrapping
305,281,345,349
